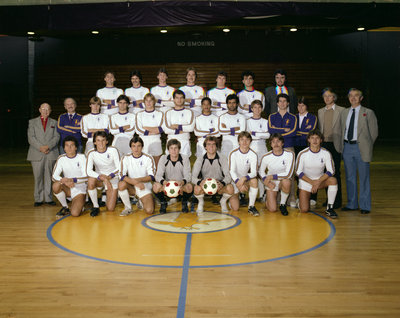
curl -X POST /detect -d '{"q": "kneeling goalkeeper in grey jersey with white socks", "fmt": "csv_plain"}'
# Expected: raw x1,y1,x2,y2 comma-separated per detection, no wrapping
192,136,234,213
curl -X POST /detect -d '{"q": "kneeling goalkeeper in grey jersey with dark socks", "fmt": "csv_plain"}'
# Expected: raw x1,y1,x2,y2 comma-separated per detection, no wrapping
153,139,193,213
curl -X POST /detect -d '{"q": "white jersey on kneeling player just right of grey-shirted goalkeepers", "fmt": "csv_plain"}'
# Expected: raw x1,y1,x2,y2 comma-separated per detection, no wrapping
228,148,258,183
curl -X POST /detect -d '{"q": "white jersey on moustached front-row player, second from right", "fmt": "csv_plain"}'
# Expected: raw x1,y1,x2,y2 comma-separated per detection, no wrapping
258,150,294,180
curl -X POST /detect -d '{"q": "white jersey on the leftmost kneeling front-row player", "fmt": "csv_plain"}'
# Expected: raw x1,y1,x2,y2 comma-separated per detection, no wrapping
52,153,87,183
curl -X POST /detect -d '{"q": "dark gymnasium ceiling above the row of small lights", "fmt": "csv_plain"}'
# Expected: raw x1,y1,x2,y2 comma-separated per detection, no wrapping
0,0,400,38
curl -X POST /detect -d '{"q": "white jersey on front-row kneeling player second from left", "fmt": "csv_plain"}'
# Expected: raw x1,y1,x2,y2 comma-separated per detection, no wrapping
86,146,120,178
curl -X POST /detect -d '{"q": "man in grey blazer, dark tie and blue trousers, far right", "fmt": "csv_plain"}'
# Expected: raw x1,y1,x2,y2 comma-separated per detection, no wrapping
340,88,378,214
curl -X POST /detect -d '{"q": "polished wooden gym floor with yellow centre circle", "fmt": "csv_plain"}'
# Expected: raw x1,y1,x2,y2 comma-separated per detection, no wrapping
0,141,400,318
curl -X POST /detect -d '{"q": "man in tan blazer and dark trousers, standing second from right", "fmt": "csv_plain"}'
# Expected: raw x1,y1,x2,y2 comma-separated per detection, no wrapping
318,87,344,209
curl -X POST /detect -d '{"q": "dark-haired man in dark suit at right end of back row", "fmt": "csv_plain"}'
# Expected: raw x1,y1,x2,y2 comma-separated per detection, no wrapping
265,69,297,117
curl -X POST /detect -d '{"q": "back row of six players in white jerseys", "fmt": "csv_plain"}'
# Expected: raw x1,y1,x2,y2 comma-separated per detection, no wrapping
96,67,268,117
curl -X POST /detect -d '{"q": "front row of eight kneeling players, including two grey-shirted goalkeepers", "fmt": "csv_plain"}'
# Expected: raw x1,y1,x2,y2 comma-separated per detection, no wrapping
53,131,337,218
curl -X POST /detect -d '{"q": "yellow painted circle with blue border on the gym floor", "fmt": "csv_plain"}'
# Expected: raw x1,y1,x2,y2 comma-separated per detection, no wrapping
47,211,336,268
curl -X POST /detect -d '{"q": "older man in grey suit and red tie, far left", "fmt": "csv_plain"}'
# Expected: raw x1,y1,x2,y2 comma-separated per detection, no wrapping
27,103,60,206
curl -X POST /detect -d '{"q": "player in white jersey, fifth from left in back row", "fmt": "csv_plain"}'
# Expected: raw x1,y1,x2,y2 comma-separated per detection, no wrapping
207,71,236,116
